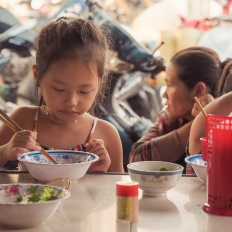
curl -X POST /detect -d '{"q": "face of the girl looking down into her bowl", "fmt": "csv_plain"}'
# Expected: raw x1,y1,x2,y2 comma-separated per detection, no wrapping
39,59,100,122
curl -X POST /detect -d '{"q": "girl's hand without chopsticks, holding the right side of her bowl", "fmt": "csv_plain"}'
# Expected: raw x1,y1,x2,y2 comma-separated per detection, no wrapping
86,139,111,172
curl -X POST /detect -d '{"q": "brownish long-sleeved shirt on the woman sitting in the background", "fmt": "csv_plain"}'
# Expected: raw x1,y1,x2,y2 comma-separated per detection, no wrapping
130,111,187,171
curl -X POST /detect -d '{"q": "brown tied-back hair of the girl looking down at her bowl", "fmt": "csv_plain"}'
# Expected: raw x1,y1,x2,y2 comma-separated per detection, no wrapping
35,17,110,108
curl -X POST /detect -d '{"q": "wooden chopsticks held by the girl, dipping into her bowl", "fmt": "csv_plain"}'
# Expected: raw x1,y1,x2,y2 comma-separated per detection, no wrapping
0,109,58,164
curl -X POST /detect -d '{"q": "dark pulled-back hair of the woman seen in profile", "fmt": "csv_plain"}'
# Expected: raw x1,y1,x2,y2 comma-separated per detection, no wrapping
171,47,221,97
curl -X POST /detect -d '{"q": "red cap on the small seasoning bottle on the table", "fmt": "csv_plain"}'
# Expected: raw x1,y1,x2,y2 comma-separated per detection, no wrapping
116,181,139,197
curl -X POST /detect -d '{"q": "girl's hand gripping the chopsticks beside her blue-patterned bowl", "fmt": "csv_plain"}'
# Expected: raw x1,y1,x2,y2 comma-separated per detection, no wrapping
6,130,41,160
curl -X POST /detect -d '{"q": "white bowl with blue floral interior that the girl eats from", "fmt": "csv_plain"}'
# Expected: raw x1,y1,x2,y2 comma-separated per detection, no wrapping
18,150,99,183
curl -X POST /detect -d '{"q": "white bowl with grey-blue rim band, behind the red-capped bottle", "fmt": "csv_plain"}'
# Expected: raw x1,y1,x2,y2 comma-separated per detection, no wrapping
127,161,184,196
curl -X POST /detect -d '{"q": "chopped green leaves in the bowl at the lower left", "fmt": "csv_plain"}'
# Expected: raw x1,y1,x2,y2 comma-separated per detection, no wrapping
17,185,62,202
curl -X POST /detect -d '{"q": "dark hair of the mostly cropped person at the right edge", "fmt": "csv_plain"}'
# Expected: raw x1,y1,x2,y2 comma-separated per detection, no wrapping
215,58,232,97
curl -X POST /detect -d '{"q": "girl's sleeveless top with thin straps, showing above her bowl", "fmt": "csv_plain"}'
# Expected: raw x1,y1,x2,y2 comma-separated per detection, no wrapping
33,107,98,151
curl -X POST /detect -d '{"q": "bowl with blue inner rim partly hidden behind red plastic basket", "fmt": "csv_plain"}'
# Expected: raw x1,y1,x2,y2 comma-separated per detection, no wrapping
185,154,207,183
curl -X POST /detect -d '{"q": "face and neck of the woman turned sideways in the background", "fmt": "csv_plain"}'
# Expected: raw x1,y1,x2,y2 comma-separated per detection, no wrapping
163,63,196,120
